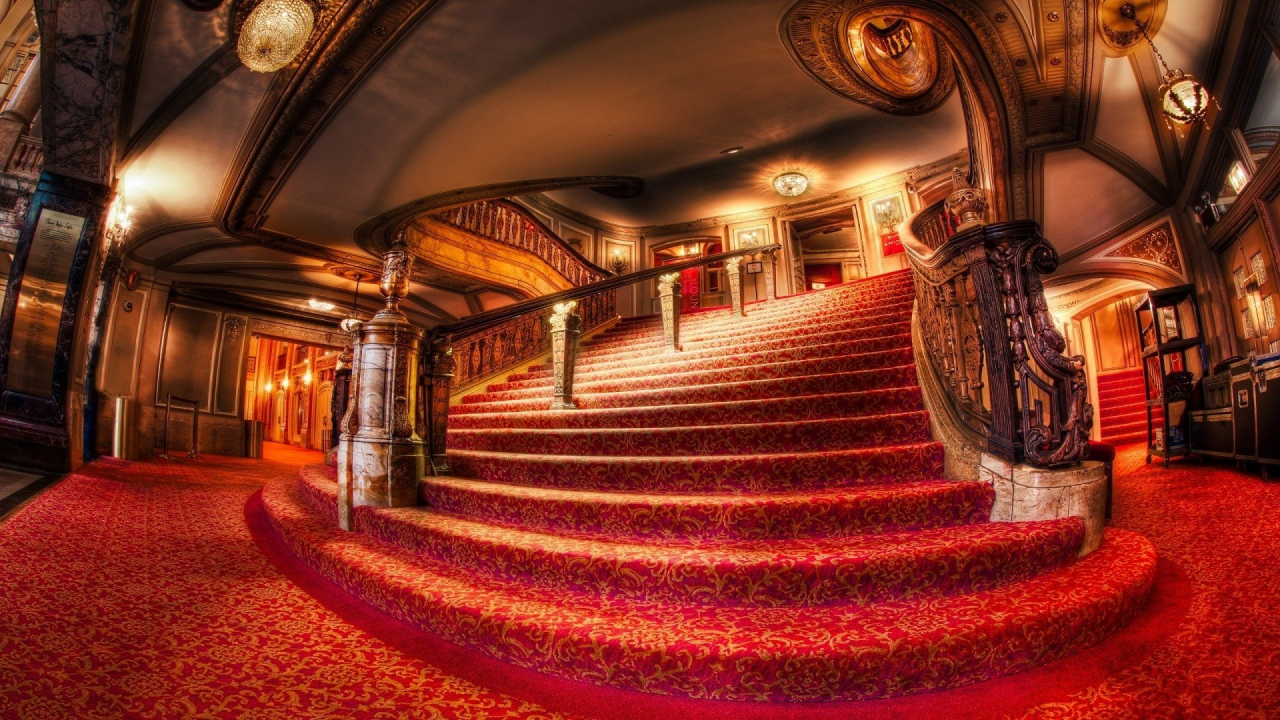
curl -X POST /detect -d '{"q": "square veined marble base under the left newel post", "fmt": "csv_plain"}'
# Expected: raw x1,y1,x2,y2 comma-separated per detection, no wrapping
338,438,426,530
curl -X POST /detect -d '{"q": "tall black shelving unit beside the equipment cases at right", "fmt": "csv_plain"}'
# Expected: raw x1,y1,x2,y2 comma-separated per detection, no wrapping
1134,284,1208,468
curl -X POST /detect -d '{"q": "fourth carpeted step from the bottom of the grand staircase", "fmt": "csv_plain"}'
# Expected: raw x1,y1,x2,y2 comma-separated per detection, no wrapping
448,442,942,493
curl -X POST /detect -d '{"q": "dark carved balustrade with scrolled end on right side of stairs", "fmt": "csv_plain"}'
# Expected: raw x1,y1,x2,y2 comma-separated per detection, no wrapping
902,202,1093,468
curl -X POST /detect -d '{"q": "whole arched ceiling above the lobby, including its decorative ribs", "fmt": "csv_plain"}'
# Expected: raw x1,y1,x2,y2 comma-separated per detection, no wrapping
112,0,1239,324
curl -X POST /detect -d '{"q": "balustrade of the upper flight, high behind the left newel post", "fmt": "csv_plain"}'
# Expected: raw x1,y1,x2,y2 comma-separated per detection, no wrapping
430,200,609,286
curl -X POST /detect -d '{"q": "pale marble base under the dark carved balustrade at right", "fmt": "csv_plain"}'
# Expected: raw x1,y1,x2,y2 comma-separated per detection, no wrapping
978,454,1107,557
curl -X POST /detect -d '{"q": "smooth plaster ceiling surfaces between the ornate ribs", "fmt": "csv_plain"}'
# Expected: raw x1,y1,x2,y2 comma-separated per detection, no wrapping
115,0,1221,325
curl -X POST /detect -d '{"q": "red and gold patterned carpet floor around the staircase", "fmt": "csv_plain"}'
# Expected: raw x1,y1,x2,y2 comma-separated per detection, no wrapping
0,445,1280,719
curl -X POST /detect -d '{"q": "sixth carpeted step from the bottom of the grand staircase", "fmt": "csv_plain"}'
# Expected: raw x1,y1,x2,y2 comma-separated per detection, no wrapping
449,386,924,430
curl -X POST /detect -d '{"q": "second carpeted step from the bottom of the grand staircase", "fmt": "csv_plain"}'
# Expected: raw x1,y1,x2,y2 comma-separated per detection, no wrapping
296,466,1084,607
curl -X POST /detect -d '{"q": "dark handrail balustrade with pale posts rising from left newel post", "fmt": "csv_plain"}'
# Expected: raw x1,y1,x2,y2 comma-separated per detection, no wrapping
416,245,781,474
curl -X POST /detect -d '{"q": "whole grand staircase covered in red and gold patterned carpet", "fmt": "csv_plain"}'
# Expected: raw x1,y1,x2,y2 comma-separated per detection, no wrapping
264,273,1156,701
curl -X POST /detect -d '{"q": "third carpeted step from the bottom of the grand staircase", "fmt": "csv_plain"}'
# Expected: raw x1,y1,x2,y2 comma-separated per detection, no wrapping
421,477,995,542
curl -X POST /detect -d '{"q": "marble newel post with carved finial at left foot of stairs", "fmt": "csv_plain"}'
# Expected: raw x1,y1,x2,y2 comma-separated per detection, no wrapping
338,243,425,529
